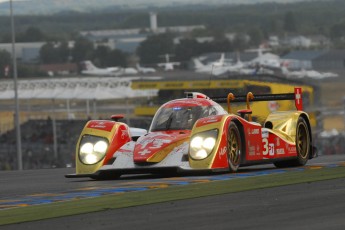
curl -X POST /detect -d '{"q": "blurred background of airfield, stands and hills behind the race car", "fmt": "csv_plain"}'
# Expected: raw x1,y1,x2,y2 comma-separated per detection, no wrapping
0,0,345,170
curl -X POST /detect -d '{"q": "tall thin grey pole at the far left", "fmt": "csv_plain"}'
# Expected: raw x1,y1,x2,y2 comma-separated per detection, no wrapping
10,0,23,170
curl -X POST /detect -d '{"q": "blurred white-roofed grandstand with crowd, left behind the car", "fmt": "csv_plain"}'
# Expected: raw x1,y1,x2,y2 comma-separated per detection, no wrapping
0,77,160,170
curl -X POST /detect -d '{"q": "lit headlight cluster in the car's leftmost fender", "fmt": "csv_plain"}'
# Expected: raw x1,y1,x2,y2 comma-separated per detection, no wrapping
79,135,109,165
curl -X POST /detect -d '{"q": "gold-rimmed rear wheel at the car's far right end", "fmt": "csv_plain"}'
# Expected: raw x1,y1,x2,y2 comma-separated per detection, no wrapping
274,117,311,167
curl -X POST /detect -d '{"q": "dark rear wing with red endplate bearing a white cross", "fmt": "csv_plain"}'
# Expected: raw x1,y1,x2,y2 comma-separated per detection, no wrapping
211,87,303,110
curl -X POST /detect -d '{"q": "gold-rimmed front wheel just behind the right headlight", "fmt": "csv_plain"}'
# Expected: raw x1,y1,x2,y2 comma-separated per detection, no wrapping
227,122,242,172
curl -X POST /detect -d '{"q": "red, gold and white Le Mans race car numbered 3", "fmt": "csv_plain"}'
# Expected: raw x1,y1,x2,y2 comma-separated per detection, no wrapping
66,88,316,179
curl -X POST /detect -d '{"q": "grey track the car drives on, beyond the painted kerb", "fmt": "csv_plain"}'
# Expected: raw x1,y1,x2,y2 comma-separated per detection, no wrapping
0,154,345,200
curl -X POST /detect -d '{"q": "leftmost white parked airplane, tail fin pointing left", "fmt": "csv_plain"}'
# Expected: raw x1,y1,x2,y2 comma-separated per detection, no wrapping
81,60,138,76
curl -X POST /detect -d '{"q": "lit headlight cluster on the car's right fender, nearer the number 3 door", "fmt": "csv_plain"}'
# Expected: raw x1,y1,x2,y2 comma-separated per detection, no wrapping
189,129,218,160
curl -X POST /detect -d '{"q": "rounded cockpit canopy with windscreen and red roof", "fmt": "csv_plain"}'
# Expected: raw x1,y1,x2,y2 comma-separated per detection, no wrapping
150,99,226,132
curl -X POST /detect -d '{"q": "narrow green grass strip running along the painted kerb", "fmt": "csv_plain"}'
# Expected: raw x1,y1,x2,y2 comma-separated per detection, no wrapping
0,167,345,225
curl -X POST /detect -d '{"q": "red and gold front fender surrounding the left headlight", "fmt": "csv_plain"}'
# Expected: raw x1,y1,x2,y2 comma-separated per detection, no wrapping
75,120,131,174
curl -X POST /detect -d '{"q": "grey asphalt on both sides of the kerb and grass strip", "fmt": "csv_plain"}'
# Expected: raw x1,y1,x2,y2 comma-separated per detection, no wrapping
0,155,345,229
